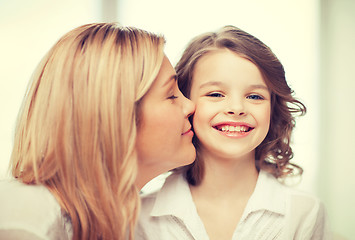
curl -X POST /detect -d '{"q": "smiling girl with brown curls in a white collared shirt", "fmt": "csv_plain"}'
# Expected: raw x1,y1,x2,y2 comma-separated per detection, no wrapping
137,26,328,240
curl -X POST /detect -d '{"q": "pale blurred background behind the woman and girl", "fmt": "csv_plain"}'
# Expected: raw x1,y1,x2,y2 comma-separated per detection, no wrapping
0,0,355,240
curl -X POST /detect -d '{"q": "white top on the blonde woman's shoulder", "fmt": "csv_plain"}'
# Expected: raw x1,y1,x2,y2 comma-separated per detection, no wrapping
0,180,72,240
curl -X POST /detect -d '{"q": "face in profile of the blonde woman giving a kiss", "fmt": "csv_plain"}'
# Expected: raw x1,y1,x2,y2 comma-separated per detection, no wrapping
136,57,196,176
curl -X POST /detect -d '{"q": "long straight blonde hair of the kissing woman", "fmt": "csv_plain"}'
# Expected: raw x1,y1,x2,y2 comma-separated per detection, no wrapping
11,23,165,239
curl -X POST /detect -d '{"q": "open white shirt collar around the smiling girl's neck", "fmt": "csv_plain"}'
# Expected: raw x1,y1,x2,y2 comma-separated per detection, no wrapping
151,170,286,219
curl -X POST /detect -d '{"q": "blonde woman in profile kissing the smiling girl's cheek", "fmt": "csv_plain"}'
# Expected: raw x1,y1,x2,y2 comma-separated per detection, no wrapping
0,23,195,239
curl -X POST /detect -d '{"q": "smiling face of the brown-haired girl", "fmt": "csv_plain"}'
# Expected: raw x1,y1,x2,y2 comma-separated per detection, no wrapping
190,49,271,158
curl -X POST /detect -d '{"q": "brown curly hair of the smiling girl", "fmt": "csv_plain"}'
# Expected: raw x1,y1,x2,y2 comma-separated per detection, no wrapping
175,26,306,185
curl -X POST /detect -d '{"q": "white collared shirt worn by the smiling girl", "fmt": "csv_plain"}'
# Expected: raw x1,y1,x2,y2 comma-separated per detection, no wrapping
136,171,331,240
